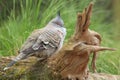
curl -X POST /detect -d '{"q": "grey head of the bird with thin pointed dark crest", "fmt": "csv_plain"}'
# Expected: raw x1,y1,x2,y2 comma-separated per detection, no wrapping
50,11,64,27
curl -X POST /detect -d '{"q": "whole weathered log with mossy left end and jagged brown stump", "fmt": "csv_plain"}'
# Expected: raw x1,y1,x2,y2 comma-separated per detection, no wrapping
0,3,120,80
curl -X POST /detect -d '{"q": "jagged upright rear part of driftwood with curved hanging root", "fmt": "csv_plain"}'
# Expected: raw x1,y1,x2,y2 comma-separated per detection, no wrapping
73,3,101,72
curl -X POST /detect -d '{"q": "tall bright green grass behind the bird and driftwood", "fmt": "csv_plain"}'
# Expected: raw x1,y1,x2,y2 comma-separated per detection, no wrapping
0,0,120,74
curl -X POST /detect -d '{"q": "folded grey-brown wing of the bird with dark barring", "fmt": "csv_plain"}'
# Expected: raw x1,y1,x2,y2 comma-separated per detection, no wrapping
20,29,61,54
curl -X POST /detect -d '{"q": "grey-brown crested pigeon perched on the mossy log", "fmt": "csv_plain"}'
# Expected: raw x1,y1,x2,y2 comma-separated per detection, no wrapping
4,11,66,70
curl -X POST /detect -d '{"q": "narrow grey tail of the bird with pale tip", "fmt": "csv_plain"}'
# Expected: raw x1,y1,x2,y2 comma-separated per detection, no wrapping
4,53,27,70
